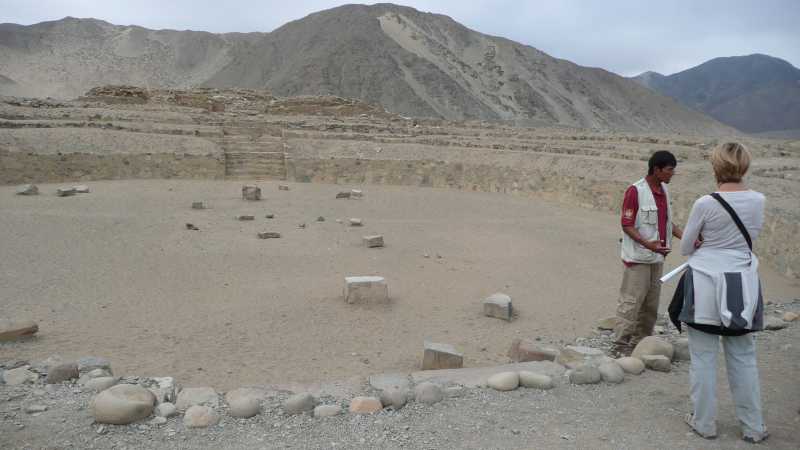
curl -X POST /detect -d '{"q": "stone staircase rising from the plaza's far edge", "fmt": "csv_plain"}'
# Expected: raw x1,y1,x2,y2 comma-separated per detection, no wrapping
220,128,286,180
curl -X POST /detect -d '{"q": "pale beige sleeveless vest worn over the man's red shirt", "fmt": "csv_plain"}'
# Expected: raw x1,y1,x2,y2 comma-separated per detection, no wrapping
622,178,672,264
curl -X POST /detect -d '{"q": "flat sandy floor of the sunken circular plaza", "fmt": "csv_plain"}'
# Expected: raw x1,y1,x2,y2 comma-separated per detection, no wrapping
0,180,800,390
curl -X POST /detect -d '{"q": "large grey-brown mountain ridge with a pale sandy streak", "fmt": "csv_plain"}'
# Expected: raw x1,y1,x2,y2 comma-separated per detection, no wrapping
0,4,732,134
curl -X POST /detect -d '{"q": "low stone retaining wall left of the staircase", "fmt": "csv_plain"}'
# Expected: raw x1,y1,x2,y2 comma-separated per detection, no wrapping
0,150,225,184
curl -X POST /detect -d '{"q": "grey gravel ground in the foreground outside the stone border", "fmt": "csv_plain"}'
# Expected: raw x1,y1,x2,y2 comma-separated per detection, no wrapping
0,299,800,449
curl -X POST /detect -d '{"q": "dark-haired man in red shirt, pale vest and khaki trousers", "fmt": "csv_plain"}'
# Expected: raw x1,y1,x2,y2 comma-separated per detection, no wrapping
614,150,683,355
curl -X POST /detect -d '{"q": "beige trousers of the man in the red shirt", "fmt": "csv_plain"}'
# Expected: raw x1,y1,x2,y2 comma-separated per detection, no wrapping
614,263,664,345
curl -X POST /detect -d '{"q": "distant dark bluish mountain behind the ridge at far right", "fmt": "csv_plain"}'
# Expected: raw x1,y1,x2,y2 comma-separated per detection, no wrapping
633,54,800,133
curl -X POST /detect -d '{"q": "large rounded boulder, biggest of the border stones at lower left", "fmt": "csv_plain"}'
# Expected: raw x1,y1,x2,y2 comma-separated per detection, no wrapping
90,384,156,425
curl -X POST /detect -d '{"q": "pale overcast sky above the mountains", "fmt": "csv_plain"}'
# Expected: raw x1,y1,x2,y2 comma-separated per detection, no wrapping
0,0,800,76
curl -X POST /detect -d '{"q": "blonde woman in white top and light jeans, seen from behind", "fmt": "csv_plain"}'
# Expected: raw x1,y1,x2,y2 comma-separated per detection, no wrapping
676,143,768,443
